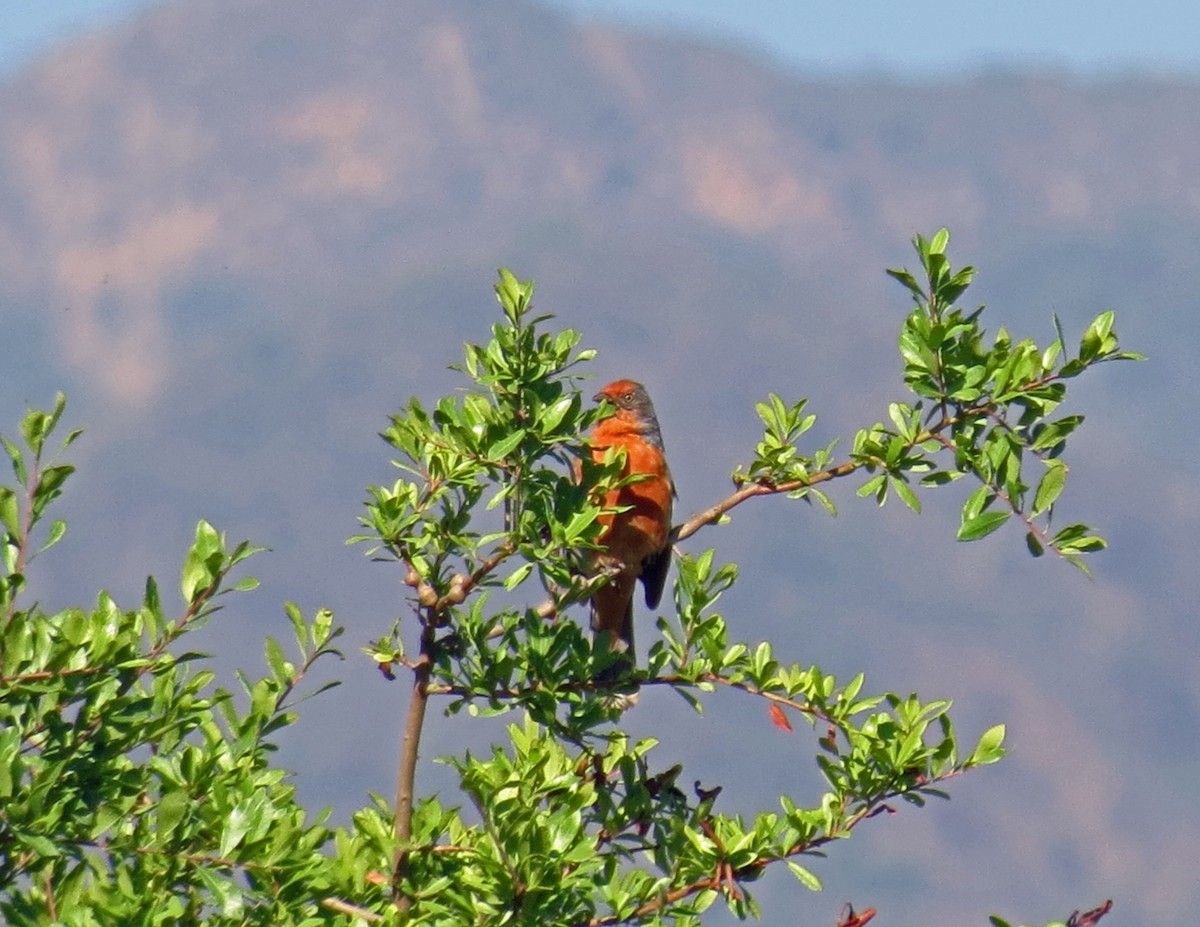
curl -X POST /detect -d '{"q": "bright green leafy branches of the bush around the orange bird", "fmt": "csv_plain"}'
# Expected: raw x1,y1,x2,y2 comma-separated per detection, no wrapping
0,231,1135,927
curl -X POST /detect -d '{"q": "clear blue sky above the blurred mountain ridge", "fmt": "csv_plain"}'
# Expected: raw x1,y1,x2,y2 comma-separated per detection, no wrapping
7,0,1200,74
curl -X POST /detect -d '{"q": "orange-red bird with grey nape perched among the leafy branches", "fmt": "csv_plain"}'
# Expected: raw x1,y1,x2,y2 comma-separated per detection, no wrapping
592,379,676,659
